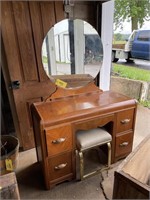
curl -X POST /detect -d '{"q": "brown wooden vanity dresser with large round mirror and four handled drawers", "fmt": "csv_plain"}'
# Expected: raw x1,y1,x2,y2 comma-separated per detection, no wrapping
31,19,136,189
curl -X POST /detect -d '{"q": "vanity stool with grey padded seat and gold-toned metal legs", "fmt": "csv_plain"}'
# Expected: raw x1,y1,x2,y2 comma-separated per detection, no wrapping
76,128,112,180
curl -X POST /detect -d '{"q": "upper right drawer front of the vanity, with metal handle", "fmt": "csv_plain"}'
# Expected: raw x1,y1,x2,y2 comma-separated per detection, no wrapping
117,109,134,133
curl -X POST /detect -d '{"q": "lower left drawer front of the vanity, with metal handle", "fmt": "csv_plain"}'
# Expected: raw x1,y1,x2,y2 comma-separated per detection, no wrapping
48,152,73,181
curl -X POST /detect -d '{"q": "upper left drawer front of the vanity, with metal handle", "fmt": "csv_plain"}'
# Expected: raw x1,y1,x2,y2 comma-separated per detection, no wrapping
46,124,72,156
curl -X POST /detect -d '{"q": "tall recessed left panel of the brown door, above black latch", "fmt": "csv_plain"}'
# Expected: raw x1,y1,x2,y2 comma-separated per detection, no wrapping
12,2,38,82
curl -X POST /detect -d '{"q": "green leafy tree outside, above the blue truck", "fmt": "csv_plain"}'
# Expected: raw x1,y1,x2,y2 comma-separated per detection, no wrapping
114,0,150,31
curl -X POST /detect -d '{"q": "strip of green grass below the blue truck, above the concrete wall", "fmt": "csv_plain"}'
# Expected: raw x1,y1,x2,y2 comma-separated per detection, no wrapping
112,64,150,82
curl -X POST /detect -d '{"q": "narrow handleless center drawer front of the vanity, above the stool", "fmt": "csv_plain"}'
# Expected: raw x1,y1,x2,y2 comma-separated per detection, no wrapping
75,115,114,130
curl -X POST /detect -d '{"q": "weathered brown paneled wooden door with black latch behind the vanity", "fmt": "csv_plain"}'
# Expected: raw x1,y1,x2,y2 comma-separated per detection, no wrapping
1,1,64,150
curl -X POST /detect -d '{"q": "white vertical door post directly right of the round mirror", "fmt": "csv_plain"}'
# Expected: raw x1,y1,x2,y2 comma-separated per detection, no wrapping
100,0,114,91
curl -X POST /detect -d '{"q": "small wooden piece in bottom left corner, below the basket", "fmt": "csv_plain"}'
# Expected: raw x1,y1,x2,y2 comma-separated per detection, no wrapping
0,172,20,199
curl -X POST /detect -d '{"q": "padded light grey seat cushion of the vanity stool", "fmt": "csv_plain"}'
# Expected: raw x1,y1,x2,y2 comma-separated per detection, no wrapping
76,128,112,151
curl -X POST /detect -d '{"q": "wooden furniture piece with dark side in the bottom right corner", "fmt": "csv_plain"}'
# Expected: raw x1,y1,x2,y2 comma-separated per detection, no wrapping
113,136,150,199
